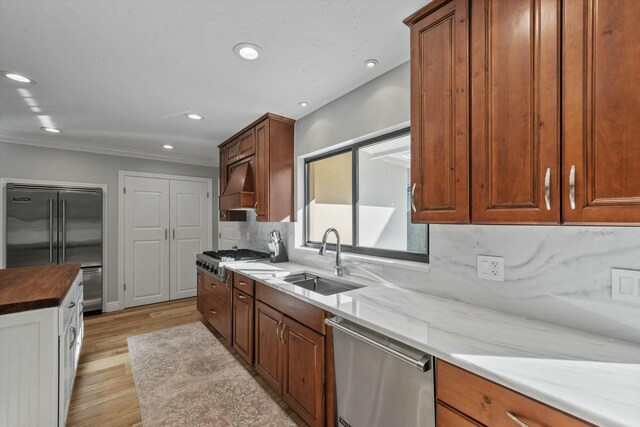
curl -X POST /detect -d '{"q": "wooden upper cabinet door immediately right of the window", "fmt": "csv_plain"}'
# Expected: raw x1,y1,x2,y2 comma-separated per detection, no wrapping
405,0,469,223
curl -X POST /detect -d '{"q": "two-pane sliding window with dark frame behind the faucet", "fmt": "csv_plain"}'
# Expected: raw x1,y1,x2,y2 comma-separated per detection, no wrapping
305,129,429,262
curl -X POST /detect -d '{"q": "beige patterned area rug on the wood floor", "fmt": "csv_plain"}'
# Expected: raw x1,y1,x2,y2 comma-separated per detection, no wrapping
127,322,295,427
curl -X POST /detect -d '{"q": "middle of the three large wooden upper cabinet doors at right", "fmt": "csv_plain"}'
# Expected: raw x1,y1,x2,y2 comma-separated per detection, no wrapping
471,0,560,224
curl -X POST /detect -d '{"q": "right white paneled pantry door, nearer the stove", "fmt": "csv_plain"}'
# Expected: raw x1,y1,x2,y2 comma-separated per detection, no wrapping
169,180,212,300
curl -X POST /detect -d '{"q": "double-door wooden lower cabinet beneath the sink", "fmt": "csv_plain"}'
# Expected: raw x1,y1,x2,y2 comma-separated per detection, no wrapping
254,282,335,427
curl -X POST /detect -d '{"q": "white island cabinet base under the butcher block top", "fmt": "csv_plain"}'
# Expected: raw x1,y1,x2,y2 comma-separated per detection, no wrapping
0,266,84,427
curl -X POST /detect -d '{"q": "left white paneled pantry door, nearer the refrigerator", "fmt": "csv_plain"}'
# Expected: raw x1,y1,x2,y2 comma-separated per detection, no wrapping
124,176,169,307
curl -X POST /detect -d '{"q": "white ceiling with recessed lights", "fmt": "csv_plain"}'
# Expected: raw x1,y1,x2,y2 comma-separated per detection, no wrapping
0,0,427,165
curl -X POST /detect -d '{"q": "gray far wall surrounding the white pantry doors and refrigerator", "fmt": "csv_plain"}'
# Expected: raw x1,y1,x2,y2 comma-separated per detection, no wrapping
0,141,218,302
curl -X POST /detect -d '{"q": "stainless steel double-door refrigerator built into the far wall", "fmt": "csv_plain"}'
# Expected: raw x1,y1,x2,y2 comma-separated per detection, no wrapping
5,184,103,312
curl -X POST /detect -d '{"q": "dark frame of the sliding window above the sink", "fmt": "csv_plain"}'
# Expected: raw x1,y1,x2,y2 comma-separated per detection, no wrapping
303,127,431,263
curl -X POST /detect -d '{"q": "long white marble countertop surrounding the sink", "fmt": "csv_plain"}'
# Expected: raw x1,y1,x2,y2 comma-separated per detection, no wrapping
226,263,640,426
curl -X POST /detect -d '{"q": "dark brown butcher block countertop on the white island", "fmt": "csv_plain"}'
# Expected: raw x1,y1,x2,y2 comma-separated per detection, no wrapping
0,264,80,315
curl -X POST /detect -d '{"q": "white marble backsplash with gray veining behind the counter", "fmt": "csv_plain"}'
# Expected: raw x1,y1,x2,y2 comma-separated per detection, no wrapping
226,218,640,343
